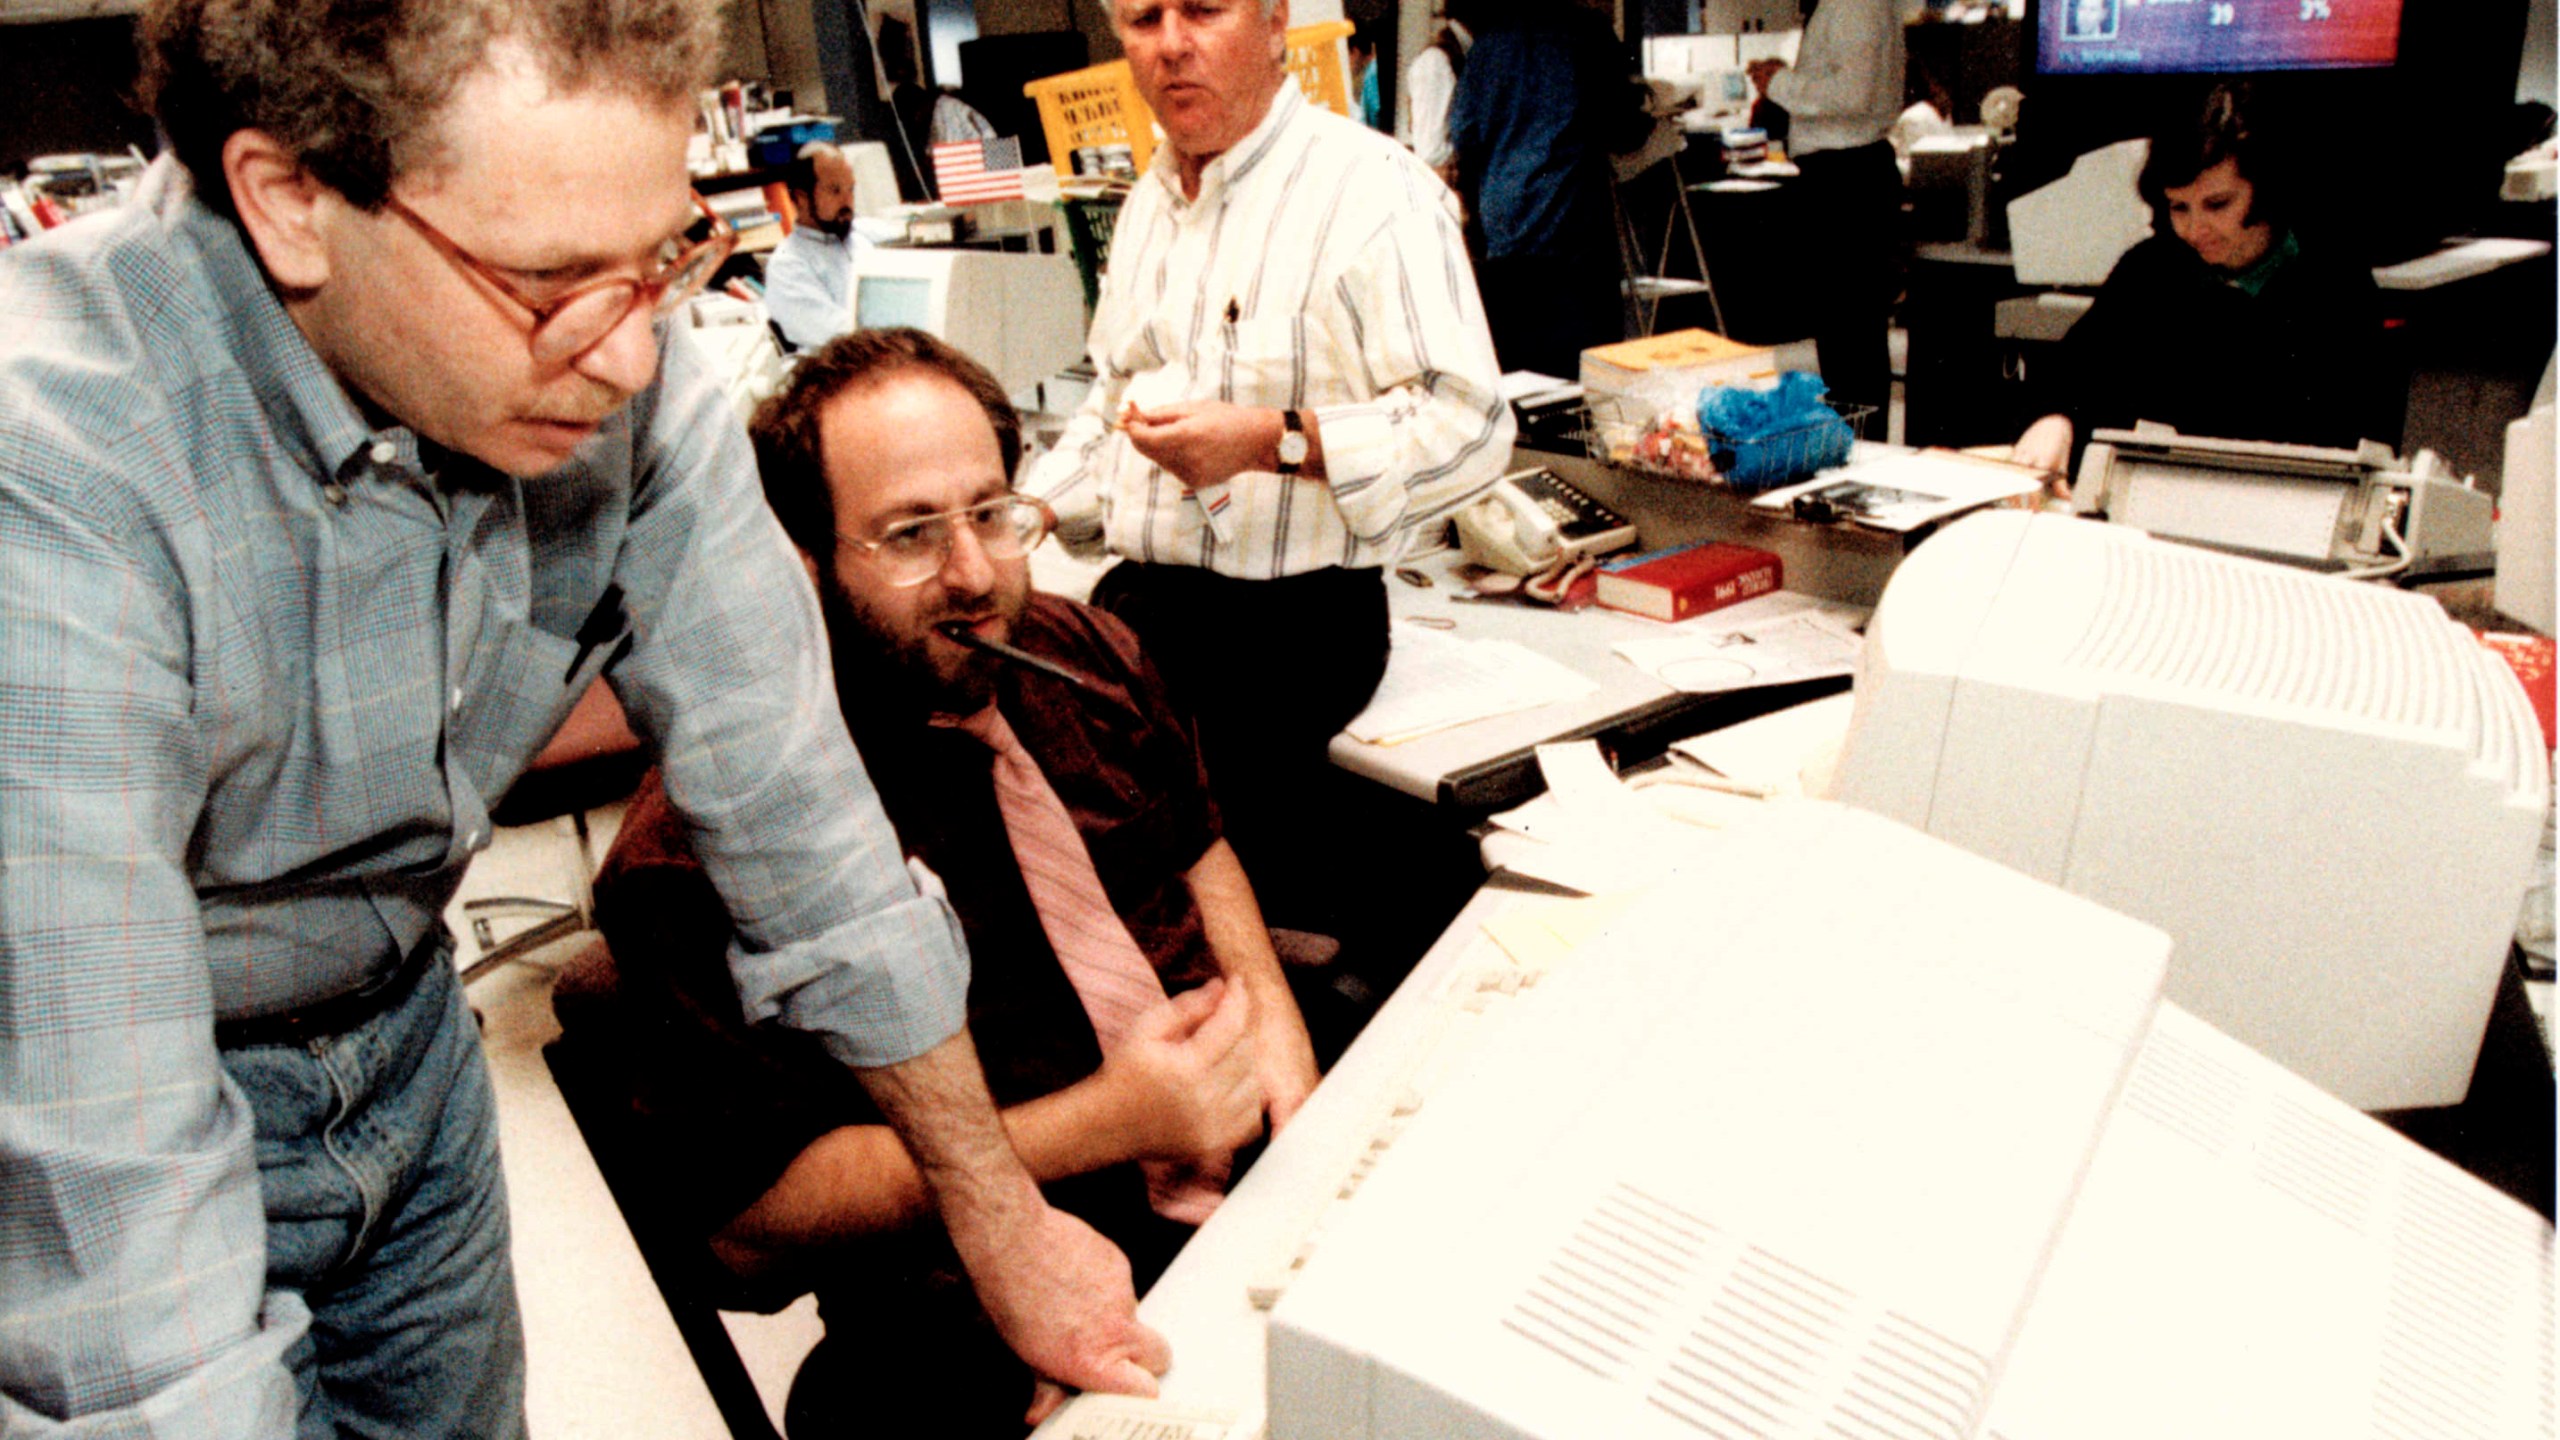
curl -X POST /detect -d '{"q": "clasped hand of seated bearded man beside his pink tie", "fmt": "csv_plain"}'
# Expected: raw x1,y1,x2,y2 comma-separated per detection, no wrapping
1103,979,1262,1163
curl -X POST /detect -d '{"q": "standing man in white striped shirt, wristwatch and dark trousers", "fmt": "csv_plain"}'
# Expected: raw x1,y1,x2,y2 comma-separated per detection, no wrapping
1024,0,1510,925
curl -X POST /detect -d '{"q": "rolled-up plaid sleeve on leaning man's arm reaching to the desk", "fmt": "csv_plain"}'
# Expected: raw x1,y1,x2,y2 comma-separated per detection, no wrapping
607,336,968,1066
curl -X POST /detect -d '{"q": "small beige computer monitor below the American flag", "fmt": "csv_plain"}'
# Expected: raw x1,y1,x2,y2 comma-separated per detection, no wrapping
852,246,1085,392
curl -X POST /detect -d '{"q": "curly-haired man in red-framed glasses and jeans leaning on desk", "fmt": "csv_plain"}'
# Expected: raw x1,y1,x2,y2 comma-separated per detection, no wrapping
0,0,1167,1437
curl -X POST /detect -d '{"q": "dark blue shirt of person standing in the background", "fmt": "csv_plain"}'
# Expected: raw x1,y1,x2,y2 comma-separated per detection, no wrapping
1449,10,1644,260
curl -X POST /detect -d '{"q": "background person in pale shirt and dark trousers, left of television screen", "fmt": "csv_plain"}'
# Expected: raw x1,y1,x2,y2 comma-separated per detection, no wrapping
1766,0,1902,413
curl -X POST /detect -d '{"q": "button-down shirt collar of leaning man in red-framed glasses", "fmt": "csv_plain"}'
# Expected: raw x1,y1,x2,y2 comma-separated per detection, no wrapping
160,156,420,484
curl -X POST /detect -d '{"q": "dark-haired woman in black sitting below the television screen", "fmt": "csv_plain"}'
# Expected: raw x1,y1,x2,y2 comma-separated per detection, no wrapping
2010,90,2401,489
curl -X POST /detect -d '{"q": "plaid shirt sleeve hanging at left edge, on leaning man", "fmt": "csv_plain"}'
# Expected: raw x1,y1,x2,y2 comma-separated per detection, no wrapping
0,394,307,1440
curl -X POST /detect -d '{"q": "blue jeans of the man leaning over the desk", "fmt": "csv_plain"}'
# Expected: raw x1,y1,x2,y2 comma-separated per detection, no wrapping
223,956,525,1440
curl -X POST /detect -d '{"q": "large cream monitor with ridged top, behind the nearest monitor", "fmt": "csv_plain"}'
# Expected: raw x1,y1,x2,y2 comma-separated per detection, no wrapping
1833,512,2550,1109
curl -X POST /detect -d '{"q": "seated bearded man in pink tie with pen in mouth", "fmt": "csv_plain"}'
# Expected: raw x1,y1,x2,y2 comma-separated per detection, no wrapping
596,331,1316,1437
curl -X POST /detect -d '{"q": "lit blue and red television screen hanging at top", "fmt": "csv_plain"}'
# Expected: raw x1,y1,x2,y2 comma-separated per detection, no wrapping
2035,0,2401,74
